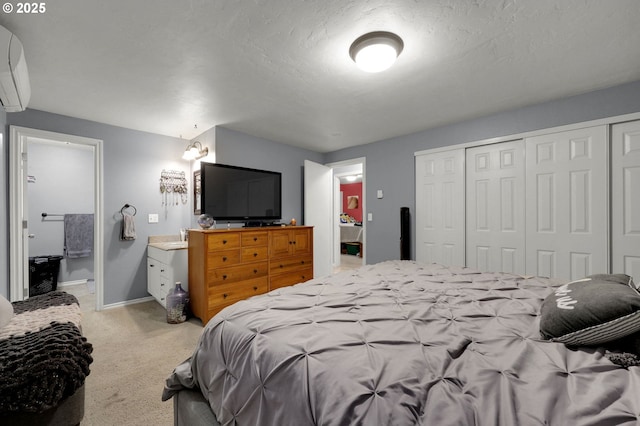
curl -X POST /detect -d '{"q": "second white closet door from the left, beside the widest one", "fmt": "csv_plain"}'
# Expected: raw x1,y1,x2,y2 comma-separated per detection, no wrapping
466,140,525,274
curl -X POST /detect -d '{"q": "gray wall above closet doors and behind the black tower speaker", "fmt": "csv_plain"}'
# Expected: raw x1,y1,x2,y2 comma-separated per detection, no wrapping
324,81,640,263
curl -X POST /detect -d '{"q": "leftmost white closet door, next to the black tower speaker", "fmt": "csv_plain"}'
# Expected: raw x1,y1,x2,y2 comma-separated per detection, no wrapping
416,149,465,265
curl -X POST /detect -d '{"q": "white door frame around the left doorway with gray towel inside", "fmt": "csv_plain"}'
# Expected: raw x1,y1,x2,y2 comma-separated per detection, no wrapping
9,126,104,311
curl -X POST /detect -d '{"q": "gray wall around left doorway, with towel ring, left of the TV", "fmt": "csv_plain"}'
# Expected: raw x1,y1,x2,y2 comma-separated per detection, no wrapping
0,110,191,305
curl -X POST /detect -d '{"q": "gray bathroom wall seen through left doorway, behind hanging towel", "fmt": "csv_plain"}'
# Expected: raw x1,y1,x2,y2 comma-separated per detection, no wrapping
27,141,94,284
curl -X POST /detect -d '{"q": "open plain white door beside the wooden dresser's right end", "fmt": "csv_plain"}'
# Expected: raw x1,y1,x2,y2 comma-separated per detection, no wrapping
304,160,333,277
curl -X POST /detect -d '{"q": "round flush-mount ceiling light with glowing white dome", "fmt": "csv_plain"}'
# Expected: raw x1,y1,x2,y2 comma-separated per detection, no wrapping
349,31,404,72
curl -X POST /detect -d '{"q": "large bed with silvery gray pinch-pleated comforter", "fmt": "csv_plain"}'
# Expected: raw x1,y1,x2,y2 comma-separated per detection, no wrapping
162,261,640,426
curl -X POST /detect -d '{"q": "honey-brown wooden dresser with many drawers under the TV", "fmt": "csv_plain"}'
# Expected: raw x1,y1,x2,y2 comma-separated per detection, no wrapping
189,226,313,324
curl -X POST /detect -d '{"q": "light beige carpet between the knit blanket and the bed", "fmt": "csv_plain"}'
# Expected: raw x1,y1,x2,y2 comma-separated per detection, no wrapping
65,284,202,426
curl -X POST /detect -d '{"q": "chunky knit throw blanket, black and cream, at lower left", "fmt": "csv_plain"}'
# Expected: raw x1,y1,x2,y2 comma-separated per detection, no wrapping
0,291,93,415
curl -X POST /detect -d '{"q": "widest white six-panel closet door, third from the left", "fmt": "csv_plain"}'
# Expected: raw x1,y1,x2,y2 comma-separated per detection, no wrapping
526,126,609,280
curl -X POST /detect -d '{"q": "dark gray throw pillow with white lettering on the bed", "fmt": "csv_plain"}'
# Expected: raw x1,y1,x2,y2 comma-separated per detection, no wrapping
540,274,640,346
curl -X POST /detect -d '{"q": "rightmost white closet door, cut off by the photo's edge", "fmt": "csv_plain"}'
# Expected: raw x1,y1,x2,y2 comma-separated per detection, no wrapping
611,121,640,284
